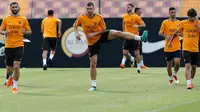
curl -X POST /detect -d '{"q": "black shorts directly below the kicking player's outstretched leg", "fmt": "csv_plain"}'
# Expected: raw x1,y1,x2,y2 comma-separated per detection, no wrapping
123,39,140,51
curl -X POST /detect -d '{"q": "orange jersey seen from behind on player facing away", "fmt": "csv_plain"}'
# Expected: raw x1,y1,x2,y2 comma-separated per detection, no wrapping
41,17,60,38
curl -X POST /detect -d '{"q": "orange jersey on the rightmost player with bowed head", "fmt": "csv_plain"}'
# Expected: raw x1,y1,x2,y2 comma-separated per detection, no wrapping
178,20,200,52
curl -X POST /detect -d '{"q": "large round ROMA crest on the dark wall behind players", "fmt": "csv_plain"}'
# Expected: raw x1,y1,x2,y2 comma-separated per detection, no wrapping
61,27,88,57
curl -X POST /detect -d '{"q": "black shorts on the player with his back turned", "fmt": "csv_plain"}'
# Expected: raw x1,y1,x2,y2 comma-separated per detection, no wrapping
42,37,57,50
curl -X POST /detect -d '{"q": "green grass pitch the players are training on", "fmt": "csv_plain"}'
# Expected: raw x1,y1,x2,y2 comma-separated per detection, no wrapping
0,68,200,112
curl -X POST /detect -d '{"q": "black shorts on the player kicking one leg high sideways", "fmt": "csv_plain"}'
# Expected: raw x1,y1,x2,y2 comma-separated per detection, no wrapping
88,30,110,57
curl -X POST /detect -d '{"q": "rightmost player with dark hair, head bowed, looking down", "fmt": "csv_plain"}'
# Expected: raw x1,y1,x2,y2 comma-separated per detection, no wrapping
168,8,200,89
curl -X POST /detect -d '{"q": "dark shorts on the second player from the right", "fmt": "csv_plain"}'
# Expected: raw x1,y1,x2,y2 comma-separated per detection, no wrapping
165,50,181,61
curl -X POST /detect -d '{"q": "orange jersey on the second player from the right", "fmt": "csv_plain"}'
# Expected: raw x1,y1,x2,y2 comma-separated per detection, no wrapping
160,19,181,52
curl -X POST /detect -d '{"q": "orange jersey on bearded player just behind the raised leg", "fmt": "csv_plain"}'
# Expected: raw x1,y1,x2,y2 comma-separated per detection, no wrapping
122,13,144,35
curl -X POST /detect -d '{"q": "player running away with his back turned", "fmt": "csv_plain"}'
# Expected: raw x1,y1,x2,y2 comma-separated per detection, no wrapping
41,10,62,70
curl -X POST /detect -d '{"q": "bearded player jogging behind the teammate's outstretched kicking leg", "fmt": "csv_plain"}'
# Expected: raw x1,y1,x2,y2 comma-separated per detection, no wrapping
120,4,146,73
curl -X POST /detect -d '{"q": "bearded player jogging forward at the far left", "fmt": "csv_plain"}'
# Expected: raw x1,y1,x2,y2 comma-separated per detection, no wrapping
0,2,32,93
